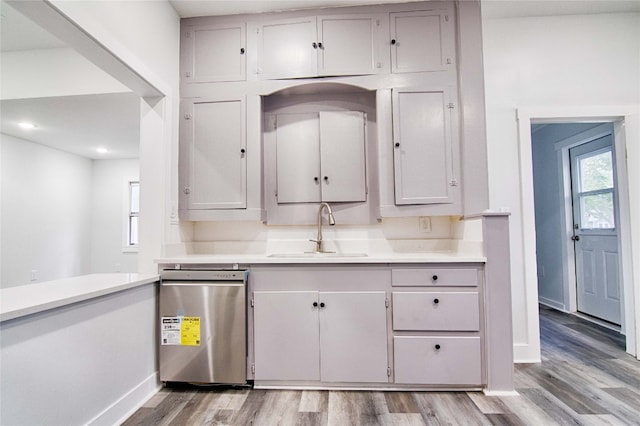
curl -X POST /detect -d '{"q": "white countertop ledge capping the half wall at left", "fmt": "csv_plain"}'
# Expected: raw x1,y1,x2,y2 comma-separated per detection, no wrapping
0,273,159,321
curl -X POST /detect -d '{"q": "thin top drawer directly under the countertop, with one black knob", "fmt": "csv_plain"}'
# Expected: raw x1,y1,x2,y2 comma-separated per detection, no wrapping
391,268,478,287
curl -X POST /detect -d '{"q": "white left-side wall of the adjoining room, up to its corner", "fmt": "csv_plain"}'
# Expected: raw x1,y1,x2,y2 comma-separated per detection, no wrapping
0,134,92,288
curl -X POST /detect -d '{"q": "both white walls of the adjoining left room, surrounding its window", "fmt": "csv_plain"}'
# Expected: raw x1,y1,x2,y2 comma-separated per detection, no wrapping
0,138,139,288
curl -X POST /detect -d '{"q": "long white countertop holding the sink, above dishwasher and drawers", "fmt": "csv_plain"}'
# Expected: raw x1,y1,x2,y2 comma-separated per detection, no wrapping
156,252,487,265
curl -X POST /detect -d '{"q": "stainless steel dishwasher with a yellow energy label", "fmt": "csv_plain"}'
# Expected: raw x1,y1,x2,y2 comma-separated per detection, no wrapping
159,270,247,384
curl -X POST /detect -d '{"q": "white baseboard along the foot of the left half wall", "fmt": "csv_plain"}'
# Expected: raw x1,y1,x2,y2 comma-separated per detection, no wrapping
87,371,161,425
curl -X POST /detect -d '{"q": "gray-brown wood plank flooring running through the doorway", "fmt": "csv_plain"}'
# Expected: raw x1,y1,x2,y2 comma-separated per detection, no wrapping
124,307,640,426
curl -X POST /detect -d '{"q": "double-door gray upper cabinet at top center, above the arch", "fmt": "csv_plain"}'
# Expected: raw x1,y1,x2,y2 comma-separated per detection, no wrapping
257,15,383,79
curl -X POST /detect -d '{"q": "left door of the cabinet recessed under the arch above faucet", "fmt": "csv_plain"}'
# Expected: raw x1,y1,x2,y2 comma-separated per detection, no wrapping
276,113,320,203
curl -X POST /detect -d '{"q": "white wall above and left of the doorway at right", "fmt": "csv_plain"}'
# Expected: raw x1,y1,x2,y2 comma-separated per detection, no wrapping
483,14,640,361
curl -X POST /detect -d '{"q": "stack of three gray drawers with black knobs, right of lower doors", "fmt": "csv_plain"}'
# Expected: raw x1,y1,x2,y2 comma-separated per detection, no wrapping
391,267,483,387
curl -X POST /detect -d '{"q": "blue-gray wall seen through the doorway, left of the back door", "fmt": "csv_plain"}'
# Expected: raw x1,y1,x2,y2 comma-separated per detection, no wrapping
531,123,599,310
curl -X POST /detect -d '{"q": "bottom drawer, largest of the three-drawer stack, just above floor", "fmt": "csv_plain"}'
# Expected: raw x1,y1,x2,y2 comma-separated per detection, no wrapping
393,336,482,386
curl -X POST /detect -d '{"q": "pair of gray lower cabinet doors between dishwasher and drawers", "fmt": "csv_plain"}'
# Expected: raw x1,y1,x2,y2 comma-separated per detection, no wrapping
253,291,388,383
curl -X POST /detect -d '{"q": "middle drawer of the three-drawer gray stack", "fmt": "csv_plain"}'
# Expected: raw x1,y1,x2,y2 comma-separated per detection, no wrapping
392,291,480,331
